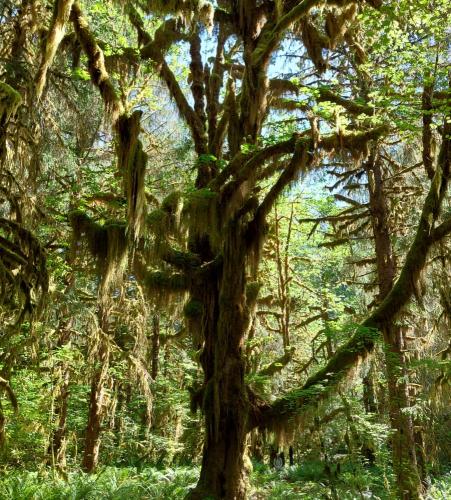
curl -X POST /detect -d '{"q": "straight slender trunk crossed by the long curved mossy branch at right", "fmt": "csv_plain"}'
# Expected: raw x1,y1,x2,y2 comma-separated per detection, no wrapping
366,152,422,500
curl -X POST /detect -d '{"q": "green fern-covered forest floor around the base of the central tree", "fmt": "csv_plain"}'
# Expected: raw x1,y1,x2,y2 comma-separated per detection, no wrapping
0,462,451,500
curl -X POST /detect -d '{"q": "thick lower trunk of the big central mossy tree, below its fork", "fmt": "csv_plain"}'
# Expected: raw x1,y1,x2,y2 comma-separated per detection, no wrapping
188,222,249,500
